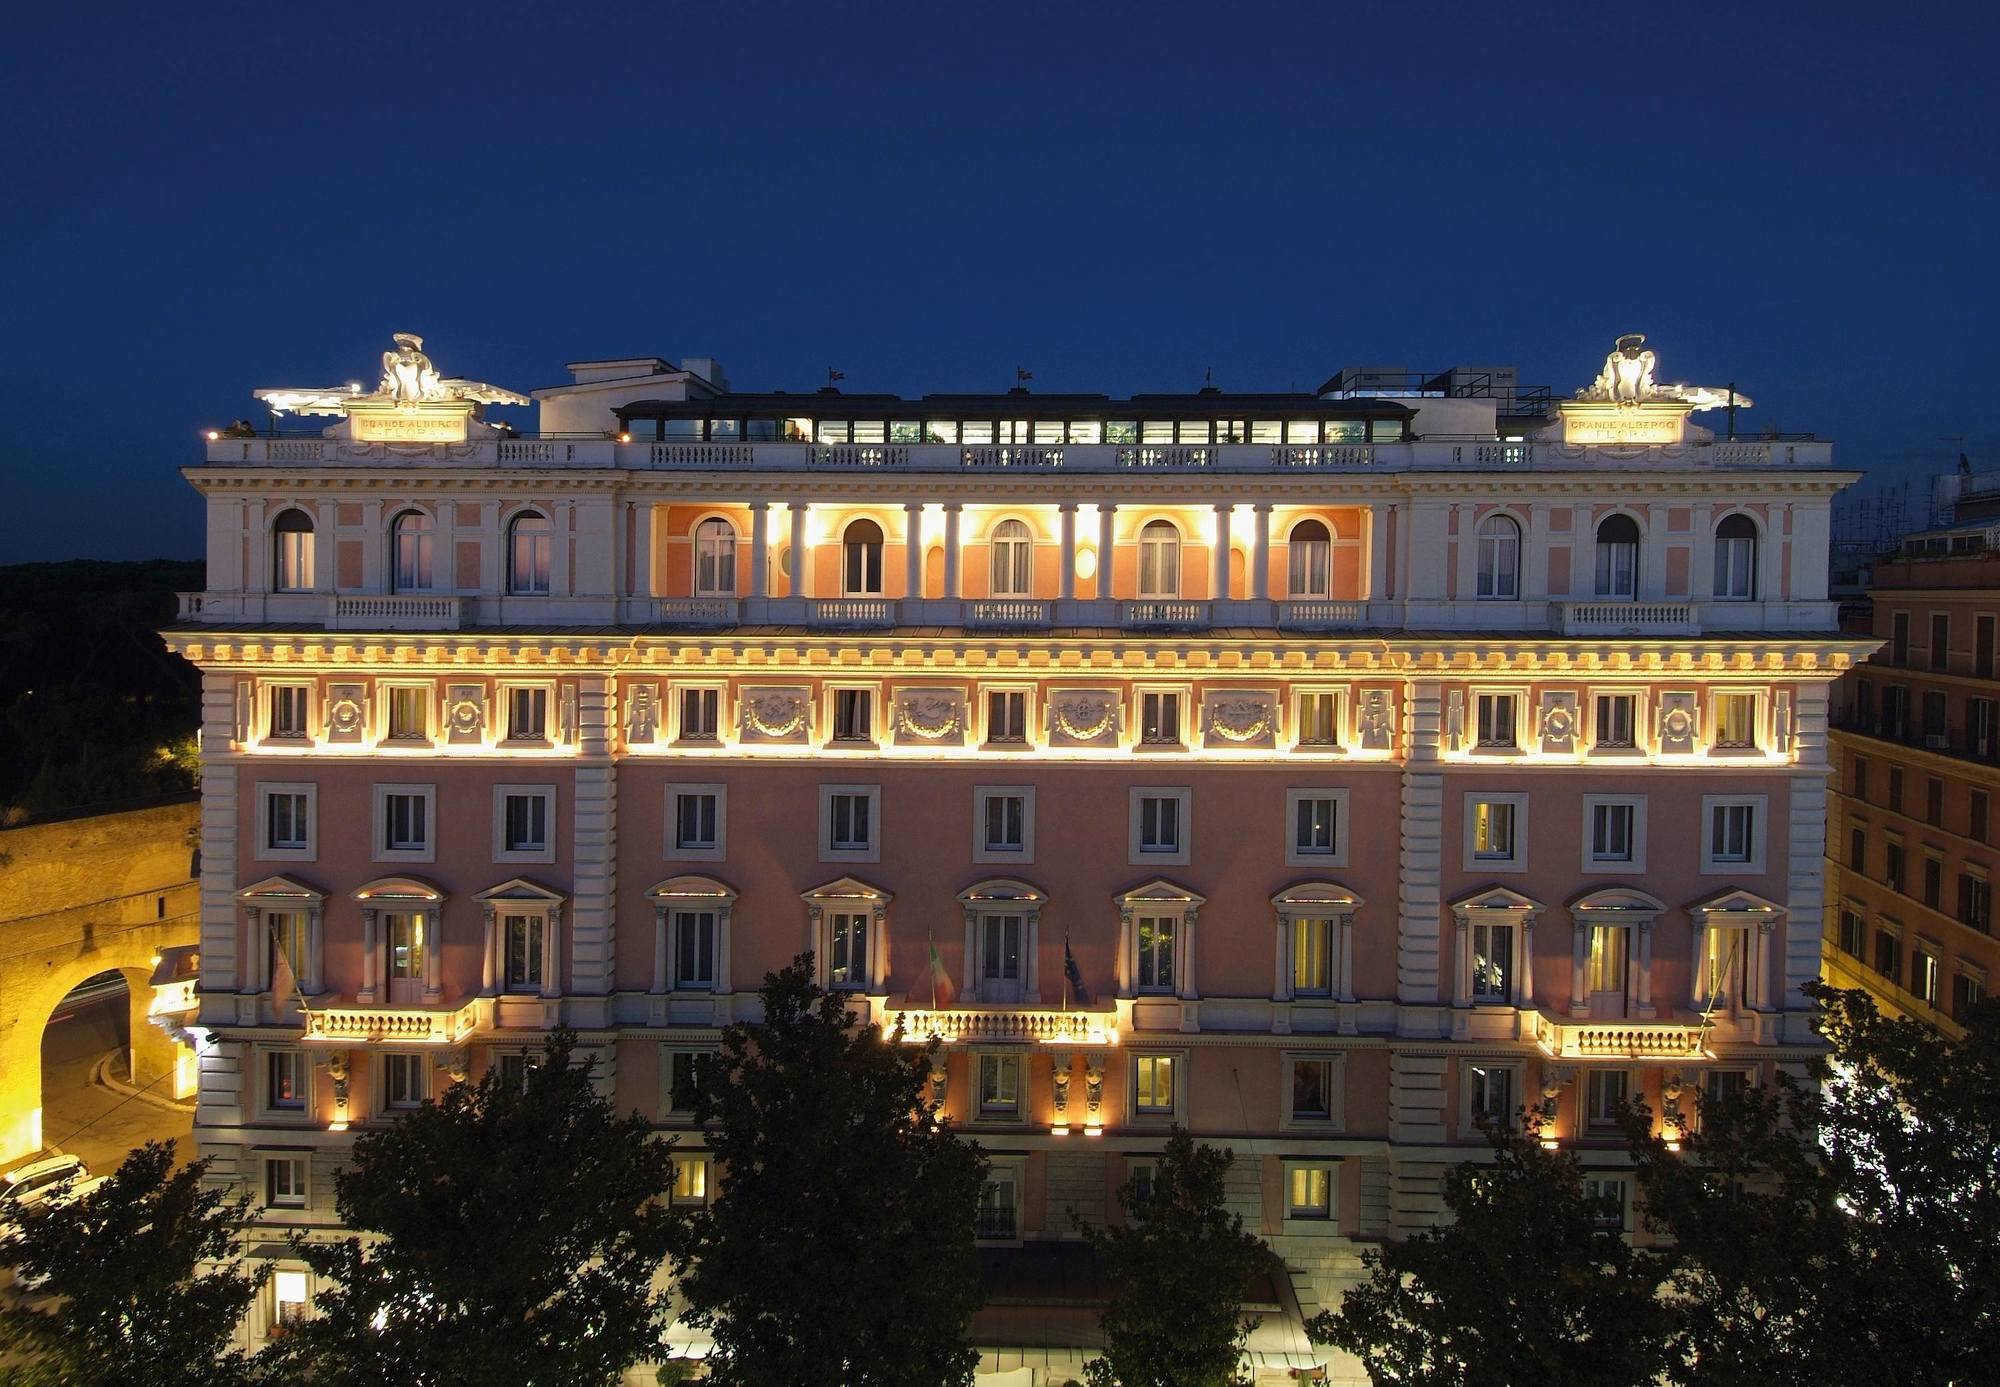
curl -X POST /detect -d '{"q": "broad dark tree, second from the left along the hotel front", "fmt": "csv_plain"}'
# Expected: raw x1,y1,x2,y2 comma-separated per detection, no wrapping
270,1029,674,1387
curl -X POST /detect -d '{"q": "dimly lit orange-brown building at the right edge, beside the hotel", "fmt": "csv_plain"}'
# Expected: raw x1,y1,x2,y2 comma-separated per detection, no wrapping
1826,524,2000,1033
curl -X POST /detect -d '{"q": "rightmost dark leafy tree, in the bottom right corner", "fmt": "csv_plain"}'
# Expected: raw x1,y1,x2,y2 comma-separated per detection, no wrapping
1630,983,2000,1387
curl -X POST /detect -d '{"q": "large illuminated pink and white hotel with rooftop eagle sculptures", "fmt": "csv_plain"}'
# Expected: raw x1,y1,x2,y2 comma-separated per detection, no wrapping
168,338,1870,1381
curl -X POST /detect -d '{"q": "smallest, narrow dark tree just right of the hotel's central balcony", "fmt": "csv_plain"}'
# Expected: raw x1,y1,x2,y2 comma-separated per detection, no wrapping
1078,1127,1272,1387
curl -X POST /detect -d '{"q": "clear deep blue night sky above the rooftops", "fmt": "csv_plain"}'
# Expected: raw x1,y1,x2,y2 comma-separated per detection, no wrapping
0,0,2000,562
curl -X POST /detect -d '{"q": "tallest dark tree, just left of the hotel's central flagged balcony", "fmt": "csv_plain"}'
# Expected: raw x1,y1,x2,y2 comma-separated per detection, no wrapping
674,953,986,1387
